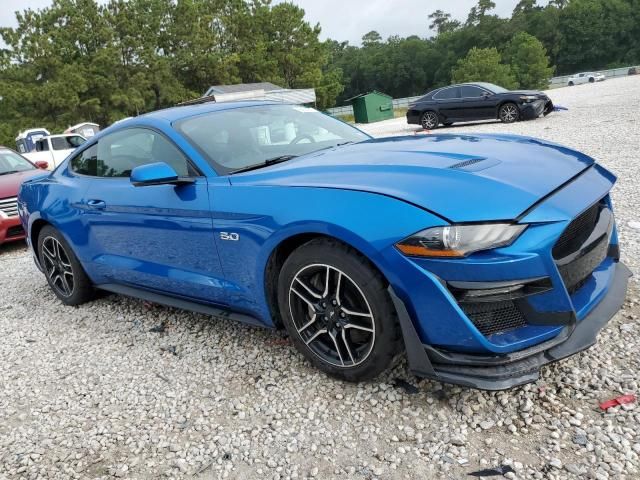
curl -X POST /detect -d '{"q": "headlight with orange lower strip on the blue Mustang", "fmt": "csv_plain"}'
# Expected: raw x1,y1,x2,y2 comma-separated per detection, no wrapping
396,223,527,258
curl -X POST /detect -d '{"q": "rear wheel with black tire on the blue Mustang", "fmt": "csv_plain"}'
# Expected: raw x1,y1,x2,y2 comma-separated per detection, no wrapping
38,225,95,305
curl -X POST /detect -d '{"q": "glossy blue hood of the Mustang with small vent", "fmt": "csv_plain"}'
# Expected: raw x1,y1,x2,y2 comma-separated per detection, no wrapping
230,134,594,222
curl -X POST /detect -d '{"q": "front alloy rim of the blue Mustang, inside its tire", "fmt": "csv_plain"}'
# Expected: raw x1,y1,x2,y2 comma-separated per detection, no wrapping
289,264,376,368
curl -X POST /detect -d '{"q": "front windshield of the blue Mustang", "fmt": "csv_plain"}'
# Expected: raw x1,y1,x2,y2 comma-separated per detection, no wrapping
175,105,369,175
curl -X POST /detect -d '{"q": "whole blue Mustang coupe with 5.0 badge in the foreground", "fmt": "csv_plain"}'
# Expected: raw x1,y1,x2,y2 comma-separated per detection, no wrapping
18,102,630,390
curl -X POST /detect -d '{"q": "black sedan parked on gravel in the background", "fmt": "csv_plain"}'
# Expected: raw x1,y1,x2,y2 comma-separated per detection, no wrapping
407,82,553,130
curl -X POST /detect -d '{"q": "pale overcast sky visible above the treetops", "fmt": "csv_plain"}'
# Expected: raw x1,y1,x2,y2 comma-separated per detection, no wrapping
0,0,517,44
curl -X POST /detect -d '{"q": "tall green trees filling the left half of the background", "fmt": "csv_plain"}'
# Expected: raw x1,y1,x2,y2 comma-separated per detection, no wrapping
0,0,343,144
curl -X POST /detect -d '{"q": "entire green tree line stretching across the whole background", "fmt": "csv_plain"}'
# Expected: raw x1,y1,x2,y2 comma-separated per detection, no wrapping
0,0,640,145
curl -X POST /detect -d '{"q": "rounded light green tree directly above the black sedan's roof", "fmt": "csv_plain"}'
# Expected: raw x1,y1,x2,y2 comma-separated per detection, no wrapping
451,47,517,89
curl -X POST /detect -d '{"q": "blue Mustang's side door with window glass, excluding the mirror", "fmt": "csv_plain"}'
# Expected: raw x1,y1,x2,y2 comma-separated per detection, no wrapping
71,127,225,304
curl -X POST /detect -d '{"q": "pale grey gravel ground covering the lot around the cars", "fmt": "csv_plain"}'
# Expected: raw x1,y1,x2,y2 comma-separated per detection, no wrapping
0,77,640,480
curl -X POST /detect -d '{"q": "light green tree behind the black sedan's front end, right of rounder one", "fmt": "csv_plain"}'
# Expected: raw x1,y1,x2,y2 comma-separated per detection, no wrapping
504,32,553,90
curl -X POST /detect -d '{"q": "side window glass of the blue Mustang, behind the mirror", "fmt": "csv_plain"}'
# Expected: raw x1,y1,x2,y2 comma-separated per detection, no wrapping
71,128,194,177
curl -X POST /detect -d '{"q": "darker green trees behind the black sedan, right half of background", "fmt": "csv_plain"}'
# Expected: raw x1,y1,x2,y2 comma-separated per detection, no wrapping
328,0,640,104
